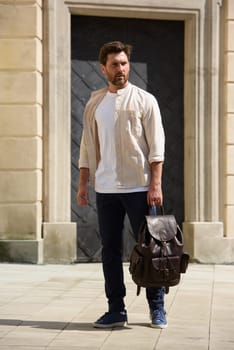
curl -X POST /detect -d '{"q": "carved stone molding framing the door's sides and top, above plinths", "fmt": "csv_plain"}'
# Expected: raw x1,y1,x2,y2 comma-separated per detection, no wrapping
44,0,230,262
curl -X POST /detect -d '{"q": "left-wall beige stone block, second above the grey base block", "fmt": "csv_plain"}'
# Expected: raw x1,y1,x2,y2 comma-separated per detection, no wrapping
0,170,42,203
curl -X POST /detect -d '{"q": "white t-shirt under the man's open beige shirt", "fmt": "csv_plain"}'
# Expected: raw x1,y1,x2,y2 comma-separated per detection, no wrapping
95,91,148,193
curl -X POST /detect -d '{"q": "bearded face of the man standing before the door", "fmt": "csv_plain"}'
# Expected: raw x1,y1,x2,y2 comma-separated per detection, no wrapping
101,51,130,89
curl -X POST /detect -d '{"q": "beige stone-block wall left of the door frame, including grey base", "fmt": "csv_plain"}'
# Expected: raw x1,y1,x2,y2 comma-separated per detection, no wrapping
0,0,42,262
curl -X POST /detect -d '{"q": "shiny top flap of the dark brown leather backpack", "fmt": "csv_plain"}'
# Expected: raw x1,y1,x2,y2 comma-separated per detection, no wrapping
145,215,177,242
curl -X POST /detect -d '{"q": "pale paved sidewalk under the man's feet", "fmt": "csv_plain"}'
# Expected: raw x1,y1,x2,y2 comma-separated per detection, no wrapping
0,264,234,350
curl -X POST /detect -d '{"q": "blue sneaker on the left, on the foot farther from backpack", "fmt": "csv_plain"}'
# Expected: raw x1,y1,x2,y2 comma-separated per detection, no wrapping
93,310,128,328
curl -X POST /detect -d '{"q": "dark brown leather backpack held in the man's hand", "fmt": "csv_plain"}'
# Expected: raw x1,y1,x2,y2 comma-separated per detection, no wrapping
129,215,189,295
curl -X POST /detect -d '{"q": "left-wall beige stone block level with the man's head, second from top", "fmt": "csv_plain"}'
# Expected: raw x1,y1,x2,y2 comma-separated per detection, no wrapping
0,38,42,72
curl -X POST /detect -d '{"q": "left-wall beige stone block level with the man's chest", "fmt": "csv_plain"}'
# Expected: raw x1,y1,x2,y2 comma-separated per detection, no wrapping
0,104,42,137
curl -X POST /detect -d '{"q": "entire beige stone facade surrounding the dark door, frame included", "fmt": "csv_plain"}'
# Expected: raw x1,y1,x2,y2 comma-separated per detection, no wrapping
0,0,234,263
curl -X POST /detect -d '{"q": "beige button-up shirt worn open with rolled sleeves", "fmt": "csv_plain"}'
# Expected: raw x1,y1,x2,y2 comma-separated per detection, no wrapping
79,83,165,188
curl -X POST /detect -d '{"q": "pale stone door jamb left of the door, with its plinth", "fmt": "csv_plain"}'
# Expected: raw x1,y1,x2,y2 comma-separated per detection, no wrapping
43,0,77,263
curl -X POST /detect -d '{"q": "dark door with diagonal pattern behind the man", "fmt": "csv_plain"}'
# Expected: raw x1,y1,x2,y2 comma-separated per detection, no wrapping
71,16,184,261
